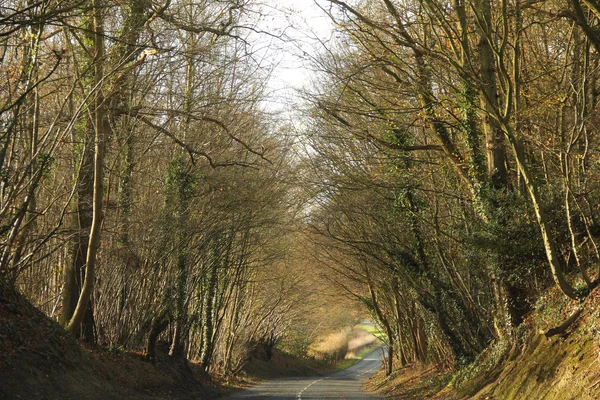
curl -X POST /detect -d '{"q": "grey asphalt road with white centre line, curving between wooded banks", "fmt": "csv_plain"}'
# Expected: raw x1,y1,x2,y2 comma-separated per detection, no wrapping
227,349,381,400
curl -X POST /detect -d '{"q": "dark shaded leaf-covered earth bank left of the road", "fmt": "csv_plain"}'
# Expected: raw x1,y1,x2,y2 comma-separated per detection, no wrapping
0,288,323,400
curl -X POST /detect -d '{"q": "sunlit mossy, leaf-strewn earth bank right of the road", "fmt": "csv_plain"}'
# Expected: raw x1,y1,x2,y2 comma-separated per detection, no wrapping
370,282,600,400
